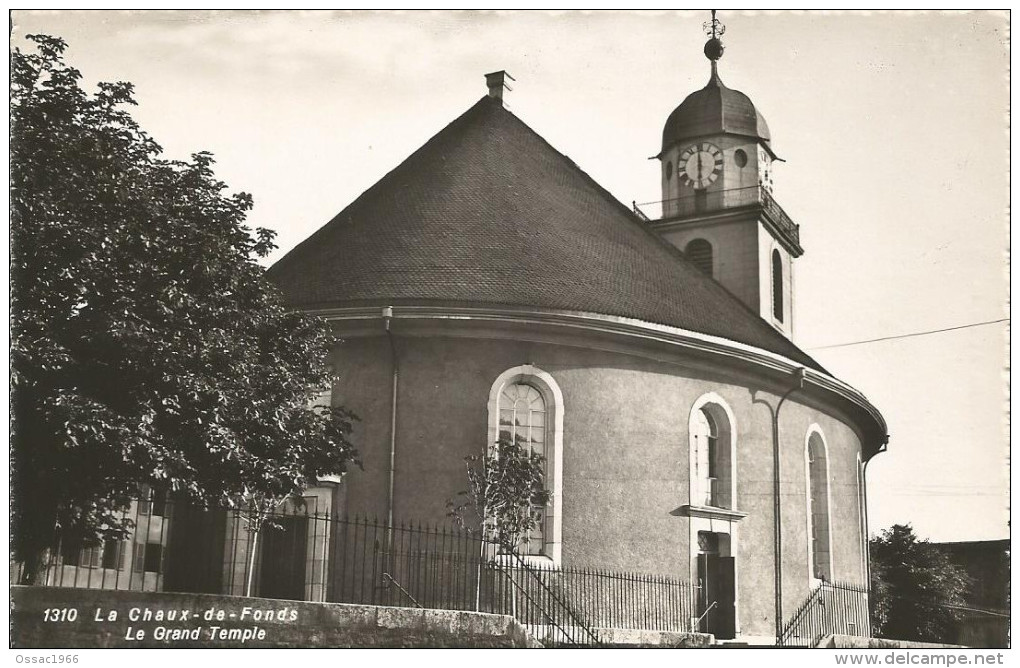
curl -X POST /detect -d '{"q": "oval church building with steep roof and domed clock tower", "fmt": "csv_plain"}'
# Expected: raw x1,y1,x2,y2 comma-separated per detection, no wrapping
268,18,887,641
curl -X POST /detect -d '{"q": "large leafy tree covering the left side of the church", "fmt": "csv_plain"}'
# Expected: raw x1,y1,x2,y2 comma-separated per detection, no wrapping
10,36,356,581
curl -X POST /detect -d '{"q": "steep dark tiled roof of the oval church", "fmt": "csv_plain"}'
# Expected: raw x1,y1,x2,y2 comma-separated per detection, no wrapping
268,97,820,369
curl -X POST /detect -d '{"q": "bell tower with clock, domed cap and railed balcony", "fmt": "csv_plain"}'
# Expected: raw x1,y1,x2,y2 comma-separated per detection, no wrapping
650,10,804,337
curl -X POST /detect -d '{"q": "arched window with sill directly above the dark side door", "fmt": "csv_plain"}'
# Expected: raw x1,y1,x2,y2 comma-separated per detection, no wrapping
690,394,734,508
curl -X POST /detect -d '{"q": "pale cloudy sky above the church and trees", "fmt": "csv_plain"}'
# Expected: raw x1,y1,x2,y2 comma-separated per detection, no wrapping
11,10,1009,541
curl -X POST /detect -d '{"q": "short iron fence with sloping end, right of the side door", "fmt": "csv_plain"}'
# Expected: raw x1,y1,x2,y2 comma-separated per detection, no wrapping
779,582,871,648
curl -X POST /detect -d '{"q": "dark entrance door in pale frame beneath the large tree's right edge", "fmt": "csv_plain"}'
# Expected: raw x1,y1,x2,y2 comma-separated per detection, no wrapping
259,516,308,601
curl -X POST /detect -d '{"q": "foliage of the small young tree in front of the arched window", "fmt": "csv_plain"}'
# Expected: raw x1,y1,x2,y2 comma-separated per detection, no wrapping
447,435,550,549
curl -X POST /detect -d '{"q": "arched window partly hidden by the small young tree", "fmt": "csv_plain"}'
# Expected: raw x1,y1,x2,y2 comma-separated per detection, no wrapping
489,364,563,563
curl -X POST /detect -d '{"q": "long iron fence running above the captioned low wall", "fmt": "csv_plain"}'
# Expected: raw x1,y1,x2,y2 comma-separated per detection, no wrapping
13,498,698,645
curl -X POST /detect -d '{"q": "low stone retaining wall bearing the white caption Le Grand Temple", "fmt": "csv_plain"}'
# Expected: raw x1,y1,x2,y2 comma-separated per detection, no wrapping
10,586,541,649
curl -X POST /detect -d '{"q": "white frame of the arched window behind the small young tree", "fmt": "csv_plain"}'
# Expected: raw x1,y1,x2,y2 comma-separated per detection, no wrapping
487,364,563,566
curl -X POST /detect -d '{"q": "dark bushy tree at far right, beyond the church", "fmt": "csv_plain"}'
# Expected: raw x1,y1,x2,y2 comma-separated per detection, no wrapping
870,524,971,643
